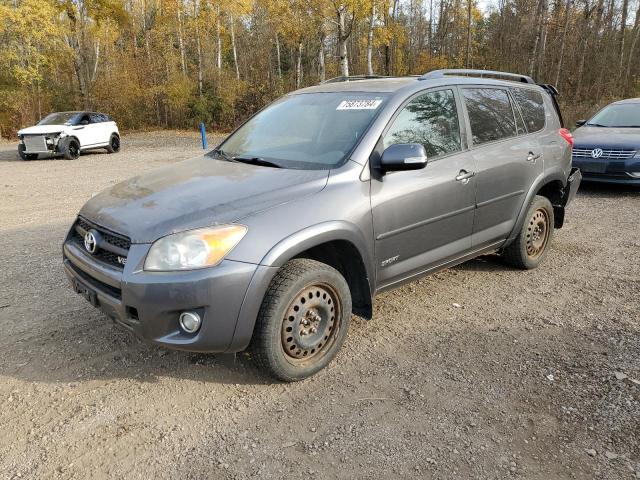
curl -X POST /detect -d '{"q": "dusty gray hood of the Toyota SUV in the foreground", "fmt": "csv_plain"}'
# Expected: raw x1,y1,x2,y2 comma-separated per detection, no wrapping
80,156,329,243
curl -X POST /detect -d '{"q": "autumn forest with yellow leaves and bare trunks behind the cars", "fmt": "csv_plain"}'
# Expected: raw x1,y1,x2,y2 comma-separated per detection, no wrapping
0,0,640,137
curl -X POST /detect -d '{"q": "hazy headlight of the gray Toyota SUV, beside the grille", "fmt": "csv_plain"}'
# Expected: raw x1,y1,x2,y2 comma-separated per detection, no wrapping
144,225,247,272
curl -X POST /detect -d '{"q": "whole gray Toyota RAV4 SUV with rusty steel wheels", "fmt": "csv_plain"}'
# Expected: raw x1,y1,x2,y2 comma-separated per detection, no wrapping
63,70,581,381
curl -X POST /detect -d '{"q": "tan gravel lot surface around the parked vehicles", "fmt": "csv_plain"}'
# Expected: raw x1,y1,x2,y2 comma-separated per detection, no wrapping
0,132,640,479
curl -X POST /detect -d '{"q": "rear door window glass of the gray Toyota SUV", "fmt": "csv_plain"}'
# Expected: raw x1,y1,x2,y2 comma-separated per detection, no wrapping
462,88,516,145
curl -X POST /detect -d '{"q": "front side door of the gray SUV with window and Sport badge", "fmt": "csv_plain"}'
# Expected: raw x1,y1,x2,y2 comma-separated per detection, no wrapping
371,88,476,288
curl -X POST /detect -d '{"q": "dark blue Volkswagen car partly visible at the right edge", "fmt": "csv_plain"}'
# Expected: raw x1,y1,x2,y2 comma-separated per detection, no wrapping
573,98,640,185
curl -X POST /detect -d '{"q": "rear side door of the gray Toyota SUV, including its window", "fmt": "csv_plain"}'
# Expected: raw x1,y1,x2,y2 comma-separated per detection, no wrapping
461,85,544,249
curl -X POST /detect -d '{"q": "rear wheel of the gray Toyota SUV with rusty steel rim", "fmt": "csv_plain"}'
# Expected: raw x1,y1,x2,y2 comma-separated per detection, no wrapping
502,195,554,270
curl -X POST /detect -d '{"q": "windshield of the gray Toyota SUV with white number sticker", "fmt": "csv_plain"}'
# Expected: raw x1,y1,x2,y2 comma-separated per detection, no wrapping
217,92,386,169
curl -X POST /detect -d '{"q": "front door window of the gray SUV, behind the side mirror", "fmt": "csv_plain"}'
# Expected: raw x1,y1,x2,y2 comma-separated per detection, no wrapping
382,90,462,158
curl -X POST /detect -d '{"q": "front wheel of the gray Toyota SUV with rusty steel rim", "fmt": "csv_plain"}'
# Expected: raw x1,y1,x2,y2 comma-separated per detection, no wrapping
249,258,351,382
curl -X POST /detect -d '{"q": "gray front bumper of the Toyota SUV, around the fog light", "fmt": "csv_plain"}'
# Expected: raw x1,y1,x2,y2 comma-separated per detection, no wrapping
63,235,275,352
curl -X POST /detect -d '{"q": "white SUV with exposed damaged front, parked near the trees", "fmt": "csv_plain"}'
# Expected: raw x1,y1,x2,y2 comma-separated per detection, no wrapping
18,112,120,160
